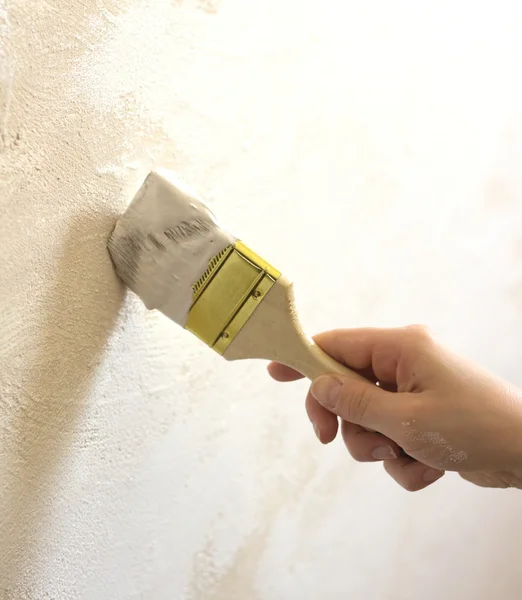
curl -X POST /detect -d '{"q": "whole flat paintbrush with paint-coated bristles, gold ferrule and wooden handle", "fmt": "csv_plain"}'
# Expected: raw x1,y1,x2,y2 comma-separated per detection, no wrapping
108,170,359,379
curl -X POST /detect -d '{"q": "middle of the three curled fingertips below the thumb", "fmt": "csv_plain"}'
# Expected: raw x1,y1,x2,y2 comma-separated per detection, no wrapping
341,421,401,462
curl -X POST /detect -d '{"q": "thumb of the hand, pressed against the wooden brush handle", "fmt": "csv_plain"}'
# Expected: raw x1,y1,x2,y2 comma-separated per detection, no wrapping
310,375,393,433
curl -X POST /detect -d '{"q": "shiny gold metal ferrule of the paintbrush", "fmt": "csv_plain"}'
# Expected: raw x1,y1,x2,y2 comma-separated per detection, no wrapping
185,242,281,354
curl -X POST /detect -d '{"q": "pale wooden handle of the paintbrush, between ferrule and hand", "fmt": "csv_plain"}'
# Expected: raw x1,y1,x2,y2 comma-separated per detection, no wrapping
223,276,363,380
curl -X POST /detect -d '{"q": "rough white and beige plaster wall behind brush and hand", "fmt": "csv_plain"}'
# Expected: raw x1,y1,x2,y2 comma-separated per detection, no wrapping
0,0,522,600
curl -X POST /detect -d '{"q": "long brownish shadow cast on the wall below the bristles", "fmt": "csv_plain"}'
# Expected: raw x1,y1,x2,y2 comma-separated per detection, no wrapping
0,209,124,599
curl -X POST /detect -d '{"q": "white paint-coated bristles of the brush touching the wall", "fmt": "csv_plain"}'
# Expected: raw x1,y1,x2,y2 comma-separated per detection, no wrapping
109,170,235,326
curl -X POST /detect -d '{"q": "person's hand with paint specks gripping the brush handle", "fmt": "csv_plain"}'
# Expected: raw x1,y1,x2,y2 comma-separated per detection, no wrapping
269,325,522,491
